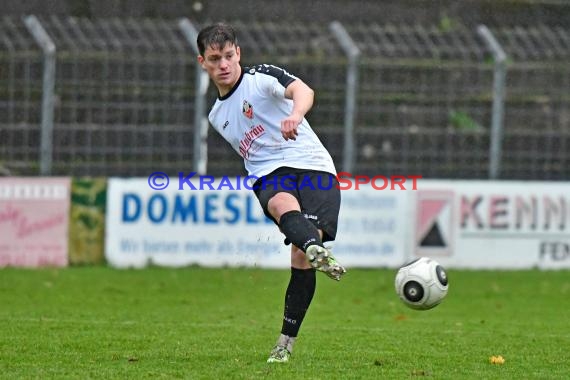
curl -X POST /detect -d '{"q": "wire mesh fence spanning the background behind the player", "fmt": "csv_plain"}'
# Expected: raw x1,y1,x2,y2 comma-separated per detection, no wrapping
0,17,570,179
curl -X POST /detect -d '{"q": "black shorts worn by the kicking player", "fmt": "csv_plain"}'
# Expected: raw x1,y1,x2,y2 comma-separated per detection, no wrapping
253,167,340,242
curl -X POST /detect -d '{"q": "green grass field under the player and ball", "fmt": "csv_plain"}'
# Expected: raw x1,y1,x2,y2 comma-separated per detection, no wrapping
0,267,570,379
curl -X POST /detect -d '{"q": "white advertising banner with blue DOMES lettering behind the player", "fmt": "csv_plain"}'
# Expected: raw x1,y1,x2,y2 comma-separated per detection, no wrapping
105,178,410,268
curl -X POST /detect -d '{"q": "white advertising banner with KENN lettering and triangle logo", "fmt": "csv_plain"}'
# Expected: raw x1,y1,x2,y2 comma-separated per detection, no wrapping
410,180,570,269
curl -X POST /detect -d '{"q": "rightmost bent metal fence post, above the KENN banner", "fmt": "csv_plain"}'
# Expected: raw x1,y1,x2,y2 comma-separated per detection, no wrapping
477,25,507,179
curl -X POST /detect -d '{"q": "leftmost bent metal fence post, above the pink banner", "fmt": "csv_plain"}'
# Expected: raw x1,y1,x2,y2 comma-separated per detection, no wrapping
24,16,56,175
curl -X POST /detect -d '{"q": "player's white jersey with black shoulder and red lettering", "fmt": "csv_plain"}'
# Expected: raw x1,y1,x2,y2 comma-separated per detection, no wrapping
208,65,336,178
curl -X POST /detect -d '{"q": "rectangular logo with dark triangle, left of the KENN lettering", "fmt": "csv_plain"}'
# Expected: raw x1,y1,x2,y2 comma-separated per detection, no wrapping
414,190,454,256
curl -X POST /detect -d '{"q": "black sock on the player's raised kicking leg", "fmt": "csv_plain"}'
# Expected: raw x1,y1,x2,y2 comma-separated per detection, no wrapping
279,211,323,252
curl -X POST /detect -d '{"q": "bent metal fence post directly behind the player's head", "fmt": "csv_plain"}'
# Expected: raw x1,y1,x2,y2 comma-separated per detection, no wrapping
178,18,210,174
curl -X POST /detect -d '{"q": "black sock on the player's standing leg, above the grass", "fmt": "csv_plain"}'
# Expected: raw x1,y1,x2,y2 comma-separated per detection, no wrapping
281,268,316,337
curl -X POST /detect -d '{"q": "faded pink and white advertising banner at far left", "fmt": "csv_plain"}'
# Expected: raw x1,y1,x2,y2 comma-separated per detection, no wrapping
0,177,71,267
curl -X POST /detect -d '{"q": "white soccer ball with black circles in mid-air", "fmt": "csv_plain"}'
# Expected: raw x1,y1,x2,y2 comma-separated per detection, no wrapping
395,257,449,310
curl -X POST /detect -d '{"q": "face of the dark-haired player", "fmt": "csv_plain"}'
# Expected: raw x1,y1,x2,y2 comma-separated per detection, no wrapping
198,44,241,95
